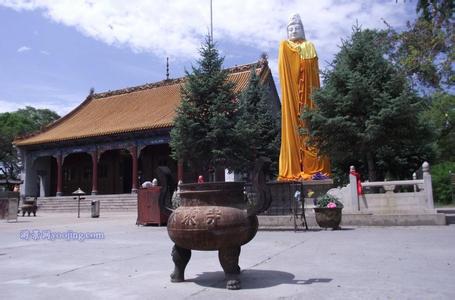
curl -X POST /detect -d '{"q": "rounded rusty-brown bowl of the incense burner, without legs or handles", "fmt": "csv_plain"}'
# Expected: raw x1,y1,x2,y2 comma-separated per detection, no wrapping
167,182,258,250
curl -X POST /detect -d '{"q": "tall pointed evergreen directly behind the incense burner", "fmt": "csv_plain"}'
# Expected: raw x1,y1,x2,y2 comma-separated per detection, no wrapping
170,37,238,178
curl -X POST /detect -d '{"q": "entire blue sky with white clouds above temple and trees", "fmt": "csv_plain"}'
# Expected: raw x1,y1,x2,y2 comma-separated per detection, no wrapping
0,0,416,115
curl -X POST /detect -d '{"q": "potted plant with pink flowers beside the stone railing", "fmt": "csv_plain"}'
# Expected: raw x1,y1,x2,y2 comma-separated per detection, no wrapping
314,194,343,230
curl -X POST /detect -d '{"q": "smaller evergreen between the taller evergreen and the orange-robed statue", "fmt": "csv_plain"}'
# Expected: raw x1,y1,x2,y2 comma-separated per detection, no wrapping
233,67,280,173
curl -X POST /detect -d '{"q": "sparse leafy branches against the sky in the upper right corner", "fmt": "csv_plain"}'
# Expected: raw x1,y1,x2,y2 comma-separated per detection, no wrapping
389,0,455,90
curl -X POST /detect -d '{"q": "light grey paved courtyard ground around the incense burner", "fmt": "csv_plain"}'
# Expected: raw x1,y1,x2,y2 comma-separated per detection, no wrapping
0,213,455,300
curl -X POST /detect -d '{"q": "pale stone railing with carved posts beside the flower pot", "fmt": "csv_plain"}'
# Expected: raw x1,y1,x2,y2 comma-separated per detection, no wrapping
328,162,434,214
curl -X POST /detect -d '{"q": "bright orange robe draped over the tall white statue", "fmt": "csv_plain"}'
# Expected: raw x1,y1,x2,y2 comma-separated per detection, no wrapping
278,40,330,181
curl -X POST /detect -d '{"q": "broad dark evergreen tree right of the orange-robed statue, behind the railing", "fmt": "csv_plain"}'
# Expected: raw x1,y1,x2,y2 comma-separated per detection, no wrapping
302,27,431,180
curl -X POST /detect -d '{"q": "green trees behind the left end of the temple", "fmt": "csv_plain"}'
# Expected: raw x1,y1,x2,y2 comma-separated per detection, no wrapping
0,106,59,178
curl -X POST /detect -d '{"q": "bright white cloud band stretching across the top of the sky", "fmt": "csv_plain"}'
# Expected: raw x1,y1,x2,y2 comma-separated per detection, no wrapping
0,0,415,62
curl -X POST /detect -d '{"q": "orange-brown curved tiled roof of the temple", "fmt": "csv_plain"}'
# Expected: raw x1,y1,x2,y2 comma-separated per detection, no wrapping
14,63,270,147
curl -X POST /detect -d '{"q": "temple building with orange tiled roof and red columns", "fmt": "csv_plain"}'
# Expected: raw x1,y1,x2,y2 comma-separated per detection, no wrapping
14,60,280,197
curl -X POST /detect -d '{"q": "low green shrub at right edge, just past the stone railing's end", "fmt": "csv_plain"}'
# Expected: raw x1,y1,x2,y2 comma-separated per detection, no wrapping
431,161,455,204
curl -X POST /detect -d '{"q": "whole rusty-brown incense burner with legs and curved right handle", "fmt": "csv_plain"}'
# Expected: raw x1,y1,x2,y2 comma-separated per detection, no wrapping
167,159,271,289
